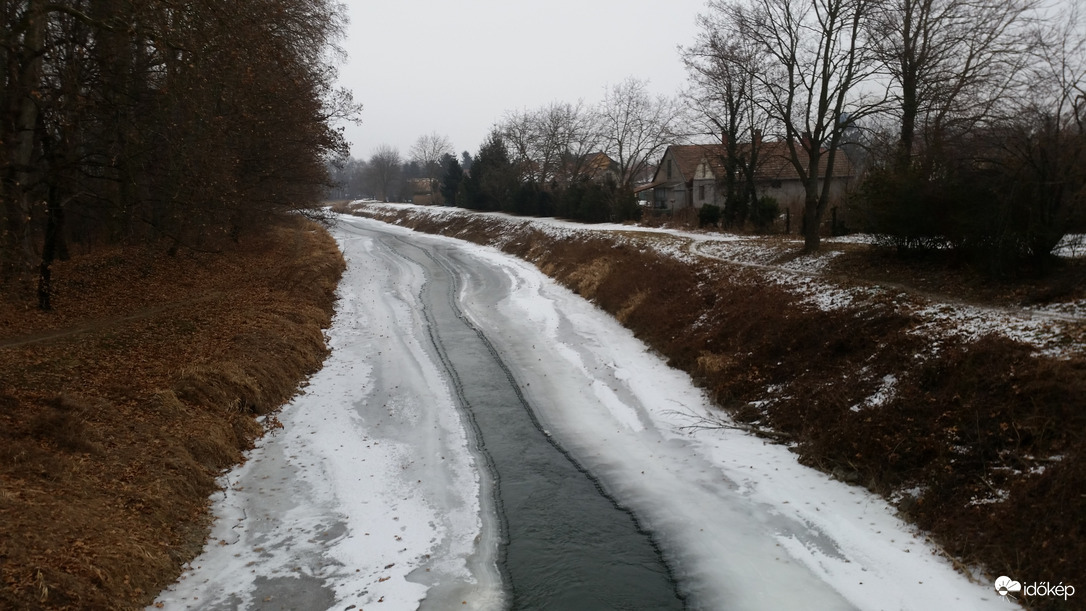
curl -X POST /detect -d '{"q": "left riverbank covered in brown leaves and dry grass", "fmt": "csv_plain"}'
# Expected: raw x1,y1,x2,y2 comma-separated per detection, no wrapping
0,219,344,609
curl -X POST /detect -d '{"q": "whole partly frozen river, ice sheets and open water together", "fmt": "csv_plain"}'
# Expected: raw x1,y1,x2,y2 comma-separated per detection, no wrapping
150,212,999,610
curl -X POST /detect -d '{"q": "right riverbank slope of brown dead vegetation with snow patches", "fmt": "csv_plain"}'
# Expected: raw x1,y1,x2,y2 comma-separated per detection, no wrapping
363,205,1086,609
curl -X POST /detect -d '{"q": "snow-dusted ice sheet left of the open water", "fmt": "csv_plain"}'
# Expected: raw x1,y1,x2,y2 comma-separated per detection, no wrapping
154,222,502,610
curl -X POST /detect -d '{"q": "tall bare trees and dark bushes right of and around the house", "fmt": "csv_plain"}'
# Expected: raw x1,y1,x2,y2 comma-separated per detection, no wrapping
682,0,1086,265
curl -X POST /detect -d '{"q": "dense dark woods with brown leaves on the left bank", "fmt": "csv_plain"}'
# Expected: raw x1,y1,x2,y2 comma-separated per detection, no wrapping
0,0,358,309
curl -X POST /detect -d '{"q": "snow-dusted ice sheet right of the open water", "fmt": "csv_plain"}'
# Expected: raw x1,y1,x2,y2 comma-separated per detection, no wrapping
447,224,999,610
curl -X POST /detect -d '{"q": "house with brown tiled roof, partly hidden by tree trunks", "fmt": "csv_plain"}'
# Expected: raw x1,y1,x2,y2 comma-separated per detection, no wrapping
636,141,855,230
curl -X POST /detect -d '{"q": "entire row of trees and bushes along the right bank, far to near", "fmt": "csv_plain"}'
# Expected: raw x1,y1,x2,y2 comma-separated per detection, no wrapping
334,0,1086,272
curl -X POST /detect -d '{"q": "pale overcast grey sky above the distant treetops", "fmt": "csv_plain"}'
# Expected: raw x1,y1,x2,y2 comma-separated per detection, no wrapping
340,0,706,158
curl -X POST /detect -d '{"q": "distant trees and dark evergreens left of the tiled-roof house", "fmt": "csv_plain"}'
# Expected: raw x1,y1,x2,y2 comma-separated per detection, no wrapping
332,77,682,222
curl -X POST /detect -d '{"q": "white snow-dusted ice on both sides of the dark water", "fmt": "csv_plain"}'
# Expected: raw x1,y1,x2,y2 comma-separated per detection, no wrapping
155,217,1010,610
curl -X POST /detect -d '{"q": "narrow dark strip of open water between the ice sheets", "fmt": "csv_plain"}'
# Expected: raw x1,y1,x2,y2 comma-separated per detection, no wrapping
395,236,683,610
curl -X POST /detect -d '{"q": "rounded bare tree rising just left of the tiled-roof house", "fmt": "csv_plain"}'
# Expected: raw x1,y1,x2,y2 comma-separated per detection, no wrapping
599,76,680,190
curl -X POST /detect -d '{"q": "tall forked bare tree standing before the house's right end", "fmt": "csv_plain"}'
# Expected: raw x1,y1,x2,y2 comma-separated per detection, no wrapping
729,0,881,252
